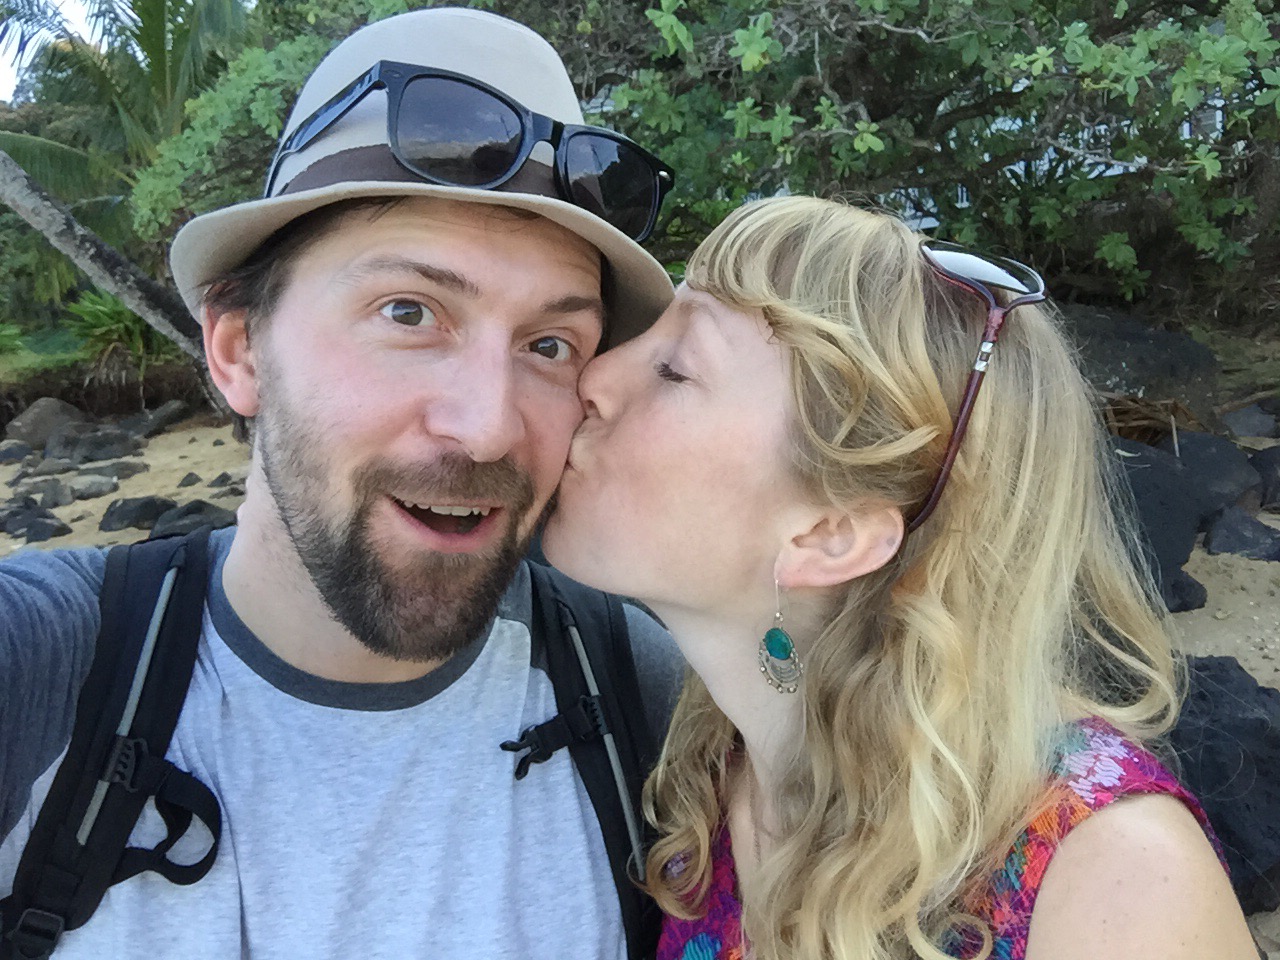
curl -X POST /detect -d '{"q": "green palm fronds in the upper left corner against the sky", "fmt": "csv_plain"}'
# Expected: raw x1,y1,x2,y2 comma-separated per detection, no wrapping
0,0,247,353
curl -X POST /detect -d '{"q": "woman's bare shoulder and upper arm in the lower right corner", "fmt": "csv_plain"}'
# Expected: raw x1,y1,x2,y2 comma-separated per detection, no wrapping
1027,795,1258,960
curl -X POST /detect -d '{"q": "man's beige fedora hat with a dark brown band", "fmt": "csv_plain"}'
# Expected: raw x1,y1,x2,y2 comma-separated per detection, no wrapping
169,8,672,343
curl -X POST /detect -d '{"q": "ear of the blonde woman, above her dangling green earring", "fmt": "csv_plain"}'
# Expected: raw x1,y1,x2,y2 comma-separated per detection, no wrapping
774,504,906,589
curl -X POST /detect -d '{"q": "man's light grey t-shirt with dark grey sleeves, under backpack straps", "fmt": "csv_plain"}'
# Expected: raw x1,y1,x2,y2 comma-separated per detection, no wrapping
0,531,678,960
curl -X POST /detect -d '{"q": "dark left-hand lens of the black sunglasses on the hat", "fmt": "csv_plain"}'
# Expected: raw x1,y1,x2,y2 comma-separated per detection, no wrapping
394,77,522,187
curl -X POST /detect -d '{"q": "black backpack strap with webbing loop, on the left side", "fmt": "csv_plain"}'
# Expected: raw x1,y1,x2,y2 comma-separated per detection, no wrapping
0,530,221,960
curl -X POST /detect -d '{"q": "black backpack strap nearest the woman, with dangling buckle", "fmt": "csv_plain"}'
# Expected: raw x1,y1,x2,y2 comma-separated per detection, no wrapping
503,563,660,960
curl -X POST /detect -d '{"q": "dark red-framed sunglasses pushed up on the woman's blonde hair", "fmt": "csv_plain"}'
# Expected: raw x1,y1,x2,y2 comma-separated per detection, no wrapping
906,239,1048,532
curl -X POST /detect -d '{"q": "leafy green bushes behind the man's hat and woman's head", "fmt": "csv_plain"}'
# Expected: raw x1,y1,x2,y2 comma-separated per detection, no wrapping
127,0,1280,325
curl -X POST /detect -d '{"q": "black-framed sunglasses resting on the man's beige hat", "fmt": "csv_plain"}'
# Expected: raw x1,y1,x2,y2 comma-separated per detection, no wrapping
264,60,675,241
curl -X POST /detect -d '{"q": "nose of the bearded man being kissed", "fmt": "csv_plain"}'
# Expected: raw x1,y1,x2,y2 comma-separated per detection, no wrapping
426,344,525,463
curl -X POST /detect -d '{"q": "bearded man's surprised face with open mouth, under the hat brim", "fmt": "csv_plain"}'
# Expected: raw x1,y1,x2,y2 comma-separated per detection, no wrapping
242,200,603,660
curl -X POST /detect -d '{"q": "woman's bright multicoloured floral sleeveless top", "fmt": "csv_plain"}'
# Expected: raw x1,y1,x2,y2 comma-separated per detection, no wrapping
658,717,1225,960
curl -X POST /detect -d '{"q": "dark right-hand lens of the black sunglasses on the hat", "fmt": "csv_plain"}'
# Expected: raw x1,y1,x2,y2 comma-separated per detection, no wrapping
563,132,658,239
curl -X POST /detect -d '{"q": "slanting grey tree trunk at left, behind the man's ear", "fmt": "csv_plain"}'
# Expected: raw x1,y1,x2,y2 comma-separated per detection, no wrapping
0,151,204,366
